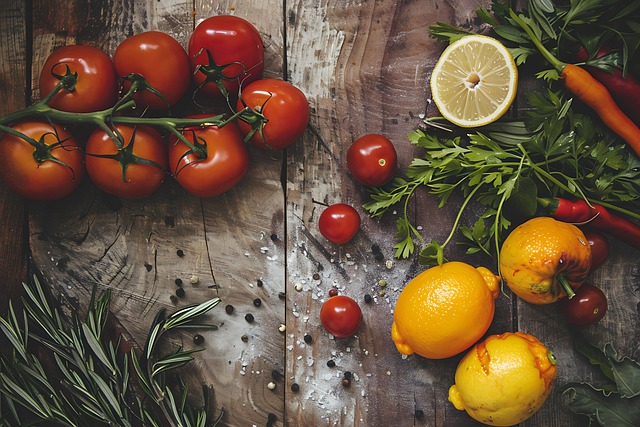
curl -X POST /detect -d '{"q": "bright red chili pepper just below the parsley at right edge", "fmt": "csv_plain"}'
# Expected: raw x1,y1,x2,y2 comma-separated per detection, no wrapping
539,198,640,249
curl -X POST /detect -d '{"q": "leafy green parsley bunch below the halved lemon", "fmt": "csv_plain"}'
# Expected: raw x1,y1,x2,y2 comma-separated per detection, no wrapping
363,91,640,264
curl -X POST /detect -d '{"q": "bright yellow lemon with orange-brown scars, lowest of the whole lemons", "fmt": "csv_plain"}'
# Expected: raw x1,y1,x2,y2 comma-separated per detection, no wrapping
449,332,556,426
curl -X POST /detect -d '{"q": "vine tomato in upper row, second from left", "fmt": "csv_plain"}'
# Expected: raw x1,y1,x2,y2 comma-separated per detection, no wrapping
113,31,191,110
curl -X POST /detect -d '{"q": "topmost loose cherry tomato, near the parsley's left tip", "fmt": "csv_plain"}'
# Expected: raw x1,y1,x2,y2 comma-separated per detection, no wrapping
347,134,398,187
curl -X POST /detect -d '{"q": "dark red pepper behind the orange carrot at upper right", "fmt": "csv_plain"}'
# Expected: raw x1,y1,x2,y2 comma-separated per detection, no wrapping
575,46,640,126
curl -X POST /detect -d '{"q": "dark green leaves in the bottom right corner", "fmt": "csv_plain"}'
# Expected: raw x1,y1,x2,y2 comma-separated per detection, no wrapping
563,338,640,427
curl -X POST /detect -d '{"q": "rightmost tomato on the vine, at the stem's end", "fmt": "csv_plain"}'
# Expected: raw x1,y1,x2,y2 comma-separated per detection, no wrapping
237,79,309,150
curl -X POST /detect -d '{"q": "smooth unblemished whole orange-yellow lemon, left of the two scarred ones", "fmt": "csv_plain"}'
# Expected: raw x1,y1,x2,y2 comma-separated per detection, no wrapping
391,262,500,359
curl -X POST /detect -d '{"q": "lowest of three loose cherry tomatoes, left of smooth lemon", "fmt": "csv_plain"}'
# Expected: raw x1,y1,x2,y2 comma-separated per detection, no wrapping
320,295,362,338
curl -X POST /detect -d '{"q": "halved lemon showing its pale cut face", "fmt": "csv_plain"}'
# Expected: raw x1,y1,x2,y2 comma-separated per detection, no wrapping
431,35,518,128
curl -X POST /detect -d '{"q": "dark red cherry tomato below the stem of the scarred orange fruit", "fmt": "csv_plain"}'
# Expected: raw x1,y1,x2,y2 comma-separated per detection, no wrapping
560,283,607,327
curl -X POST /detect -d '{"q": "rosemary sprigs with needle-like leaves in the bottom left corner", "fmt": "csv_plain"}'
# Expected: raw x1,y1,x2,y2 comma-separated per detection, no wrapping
0,276,223,427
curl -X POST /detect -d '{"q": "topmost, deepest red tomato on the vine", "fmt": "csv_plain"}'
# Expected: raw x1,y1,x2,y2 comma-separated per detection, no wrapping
189,15,264,95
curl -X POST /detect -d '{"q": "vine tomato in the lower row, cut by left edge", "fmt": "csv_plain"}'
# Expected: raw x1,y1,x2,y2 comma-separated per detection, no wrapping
0,121,85,200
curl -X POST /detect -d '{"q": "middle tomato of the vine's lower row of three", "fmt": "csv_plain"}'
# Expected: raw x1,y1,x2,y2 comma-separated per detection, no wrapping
85,125,167,199
